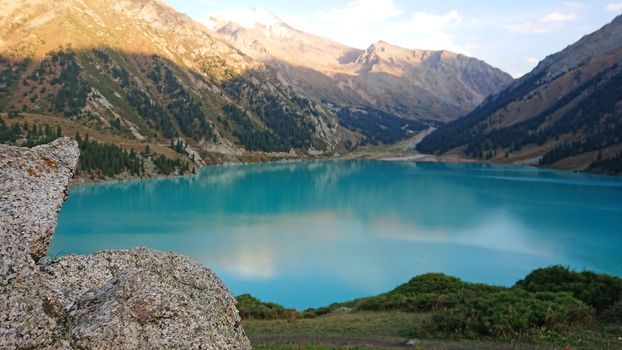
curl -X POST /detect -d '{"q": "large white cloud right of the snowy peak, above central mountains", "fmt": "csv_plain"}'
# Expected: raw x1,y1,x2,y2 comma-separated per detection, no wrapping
284,0,468,53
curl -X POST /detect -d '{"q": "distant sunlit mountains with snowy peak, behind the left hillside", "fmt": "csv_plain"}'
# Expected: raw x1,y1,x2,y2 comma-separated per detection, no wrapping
208,9,512,122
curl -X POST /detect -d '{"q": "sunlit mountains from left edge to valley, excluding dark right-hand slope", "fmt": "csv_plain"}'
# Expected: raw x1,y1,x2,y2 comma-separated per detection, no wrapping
0,0,512,162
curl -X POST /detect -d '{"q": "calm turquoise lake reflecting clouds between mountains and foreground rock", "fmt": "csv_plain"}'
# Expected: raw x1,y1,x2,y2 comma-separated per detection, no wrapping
49,161,622,309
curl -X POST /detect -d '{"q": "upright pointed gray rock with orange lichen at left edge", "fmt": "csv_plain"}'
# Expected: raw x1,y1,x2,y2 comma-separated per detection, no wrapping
0,138,80,260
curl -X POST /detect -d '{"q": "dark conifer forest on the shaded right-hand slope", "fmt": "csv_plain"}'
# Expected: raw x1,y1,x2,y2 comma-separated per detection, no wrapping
417,60,622,175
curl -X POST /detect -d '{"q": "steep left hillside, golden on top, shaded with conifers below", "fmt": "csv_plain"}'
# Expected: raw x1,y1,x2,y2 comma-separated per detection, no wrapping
0,0,338,167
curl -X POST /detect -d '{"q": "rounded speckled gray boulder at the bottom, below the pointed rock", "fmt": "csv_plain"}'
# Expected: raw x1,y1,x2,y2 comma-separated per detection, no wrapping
43,248,250,349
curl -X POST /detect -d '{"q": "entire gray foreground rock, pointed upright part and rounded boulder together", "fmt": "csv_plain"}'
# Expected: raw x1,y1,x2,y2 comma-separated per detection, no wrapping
0,138,250,349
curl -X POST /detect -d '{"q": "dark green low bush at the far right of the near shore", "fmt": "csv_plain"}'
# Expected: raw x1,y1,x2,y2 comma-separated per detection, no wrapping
516,266,622,314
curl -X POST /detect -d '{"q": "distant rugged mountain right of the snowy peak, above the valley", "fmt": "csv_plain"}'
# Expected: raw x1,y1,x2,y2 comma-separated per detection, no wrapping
352,41,512,122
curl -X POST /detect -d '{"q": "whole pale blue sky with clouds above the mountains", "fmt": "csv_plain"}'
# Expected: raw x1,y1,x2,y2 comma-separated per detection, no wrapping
165,0,622,76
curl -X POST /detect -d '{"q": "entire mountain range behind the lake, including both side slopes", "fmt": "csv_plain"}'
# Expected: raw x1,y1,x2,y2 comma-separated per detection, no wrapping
0,0,622,174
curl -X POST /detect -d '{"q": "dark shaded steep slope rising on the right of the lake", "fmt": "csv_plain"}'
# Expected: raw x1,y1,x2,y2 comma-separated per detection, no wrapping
418,16,622,174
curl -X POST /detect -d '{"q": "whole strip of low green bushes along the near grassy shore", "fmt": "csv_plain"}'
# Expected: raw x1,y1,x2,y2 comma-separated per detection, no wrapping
238,266,622,344
